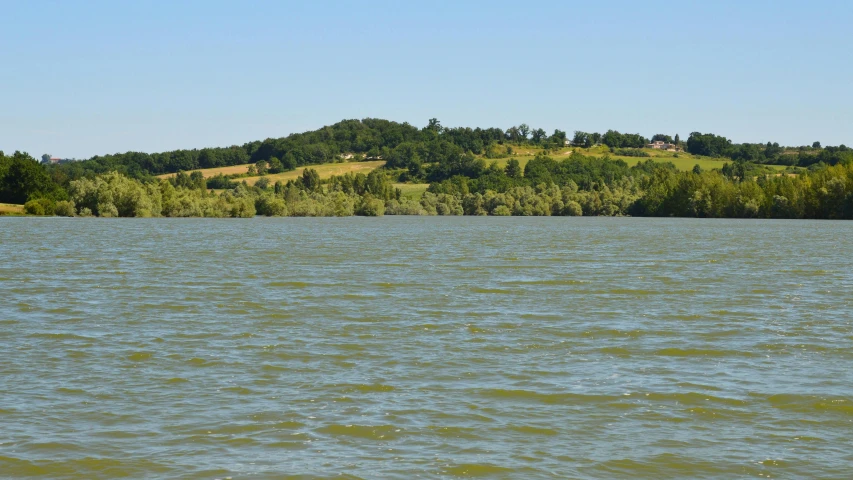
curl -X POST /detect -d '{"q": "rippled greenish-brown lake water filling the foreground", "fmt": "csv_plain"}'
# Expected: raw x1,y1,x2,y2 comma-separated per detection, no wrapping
0,217,853,479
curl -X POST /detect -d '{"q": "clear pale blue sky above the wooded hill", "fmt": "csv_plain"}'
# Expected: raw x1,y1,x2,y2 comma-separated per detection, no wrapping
0,0,853,158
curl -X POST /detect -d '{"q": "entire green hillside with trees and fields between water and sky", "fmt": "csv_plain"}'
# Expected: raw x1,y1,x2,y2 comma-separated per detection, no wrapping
0,119,853,219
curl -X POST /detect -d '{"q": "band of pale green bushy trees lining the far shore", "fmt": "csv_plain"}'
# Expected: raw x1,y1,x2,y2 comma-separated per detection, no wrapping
6,156,853,219
